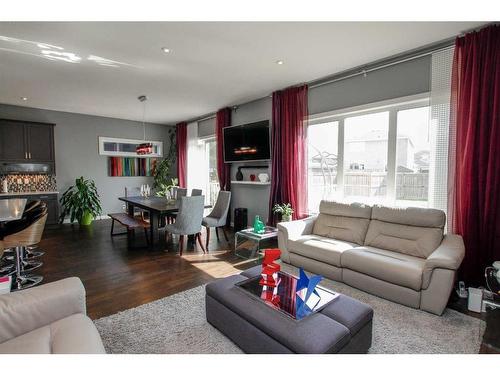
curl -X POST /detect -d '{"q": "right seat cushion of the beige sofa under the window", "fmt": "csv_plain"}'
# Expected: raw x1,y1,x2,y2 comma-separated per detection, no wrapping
342,246,425,291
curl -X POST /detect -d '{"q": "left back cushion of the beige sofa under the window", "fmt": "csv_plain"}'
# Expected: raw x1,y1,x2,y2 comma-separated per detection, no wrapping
312,201,371,245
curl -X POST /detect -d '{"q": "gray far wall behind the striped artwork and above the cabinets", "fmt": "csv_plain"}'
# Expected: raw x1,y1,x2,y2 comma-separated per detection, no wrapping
0,104,175,214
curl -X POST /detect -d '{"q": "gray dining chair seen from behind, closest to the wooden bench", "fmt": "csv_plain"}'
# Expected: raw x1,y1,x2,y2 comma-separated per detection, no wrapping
165,195,205,256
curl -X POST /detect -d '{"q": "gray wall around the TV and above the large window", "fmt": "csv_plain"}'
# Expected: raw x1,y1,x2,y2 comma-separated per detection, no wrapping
222,56,431,224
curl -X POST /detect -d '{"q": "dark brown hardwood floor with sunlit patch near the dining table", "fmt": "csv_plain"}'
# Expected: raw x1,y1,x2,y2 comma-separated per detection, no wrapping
37,220,500,353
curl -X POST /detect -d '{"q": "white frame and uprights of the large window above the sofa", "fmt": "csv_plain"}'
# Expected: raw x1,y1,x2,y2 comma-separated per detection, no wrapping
307,92,431,213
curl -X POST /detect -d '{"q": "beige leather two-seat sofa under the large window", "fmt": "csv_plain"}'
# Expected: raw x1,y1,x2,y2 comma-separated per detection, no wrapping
278,201,465,315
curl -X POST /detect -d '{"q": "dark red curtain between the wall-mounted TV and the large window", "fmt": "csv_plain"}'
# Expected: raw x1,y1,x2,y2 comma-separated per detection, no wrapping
269,85,309,225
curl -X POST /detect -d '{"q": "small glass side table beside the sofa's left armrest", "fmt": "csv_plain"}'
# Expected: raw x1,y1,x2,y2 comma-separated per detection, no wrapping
234,227,278,260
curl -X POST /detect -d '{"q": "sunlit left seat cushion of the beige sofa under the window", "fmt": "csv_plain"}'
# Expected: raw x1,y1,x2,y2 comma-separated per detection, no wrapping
288,234,357,267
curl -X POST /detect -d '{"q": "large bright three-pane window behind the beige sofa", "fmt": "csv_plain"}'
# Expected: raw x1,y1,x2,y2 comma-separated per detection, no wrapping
308,97,440,212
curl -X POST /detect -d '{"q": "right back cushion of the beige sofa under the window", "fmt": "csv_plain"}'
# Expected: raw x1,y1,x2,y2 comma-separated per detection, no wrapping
365,206,445,258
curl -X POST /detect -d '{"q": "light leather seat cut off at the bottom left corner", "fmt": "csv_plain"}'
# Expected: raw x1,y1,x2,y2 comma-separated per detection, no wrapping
0,277,105,354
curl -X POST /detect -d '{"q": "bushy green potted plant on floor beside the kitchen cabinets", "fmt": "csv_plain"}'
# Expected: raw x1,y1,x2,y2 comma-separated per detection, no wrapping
59,176,102,225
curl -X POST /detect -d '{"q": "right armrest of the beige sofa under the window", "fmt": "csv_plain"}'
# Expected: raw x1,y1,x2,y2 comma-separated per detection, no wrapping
422,234,465,289
